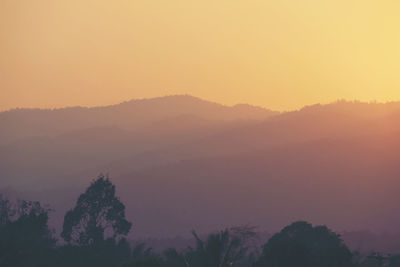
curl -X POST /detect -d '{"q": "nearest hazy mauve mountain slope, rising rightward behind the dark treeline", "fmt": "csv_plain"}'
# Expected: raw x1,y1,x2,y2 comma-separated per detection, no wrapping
114,132,400,236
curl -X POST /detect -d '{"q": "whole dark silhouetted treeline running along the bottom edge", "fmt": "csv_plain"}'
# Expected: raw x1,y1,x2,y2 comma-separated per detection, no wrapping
0,176,400,267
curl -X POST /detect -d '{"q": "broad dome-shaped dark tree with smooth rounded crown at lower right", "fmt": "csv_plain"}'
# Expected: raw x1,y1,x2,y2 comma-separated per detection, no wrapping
256,222,353,267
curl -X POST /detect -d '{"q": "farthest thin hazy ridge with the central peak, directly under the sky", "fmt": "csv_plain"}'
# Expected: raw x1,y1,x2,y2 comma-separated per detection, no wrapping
0,95,278,145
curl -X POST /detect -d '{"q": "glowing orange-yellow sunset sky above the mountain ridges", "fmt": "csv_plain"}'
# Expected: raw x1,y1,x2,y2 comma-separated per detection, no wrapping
0,0,400,110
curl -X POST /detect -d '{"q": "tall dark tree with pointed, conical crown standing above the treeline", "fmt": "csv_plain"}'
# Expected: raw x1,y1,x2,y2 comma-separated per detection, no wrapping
61,174,132,246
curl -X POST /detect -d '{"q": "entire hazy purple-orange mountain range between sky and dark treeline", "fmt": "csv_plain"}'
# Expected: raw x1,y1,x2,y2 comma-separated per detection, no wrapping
0,96,400,241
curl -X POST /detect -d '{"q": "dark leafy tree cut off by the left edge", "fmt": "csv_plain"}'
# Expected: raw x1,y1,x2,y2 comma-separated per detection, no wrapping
0,197,56,267
